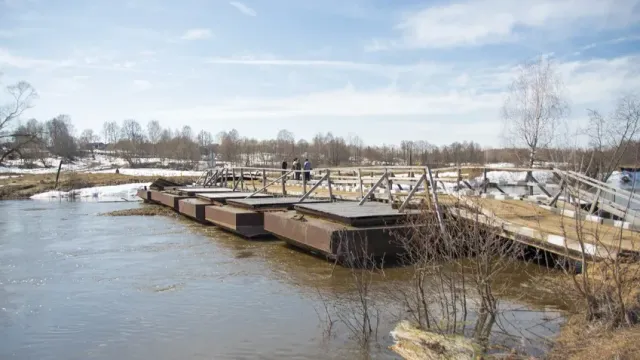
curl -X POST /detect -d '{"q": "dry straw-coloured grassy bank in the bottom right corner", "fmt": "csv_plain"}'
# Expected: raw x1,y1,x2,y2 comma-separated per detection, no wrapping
548,259,640,360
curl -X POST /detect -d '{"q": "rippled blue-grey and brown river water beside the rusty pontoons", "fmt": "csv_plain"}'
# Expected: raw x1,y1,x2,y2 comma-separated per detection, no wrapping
0,201,558,359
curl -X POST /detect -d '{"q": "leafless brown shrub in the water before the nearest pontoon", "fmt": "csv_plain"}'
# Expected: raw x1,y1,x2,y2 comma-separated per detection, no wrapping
392,204,524,351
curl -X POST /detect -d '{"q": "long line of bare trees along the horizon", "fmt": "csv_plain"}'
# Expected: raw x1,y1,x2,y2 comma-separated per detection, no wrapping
0,58,640,177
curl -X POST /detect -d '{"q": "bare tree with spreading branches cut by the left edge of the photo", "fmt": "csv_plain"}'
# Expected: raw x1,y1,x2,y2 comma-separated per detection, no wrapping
0,81,38,164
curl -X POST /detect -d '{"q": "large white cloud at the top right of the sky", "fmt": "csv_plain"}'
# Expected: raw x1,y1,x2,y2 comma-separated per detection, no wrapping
366,0,640,51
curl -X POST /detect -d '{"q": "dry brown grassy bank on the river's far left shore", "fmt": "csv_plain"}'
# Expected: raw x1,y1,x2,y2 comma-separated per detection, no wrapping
0,173,196,200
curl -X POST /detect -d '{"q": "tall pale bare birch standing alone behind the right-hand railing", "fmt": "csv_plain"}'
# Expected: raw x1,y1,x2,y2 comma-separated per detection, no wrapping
502,57,568,166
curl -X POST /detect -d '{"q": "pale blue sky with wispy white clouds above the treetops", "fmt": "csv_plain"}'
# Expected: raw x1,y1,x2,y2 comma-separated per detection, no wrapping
0,0,640,147
